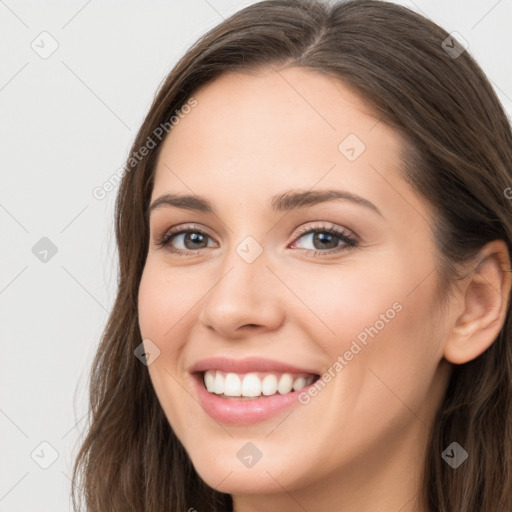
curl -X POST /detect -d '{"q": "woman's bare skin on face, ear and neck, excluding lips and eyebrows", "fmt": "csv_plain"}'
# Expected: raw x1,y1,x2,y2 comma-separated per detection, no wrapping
139,68,511,512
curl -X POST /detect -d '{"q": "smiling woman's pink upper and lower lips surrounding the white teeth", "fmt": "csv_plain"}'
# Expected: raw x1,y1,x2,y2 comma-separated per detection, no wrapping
189,357,318,425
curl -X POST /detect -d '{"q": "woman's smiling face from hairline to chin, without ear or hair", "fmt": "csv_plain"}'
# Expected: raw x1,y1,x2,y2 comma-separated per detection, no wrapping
139,68,452,506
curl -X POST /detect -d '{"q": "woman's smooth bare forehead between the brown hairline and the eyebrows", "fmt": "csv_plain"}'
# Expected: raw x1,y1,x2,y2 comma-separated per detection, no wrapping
153,68,420,220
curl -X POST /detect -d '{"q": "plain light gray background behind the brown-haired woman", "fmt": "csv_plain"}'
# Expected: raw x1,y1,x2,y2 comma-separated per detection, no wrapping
0,0,512,512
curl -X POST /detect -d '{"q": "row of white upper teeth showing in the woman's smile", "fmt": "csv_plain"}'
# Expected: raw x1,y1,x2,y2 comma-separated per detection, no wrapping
203,370,314,397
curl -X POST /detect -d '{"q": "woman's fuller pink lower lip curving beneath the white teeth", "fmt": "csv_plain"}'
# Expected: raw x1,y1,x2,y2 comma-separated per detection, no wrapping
192,374,315,425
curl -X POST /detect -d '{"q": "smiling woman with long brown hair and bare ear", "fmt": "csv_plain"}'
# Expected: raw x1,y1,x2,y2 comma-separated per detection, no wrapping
73,0,512,512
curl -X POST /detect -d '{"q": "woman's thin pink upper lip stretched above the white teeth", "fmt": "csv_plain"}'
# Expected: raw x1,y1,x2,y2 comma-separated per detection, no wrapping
189,357,318,375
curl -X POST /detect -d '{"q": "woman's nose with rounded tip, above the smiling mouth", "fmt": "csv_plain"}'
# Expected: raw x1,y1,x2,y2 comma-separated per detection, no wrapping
199,250,285,338
